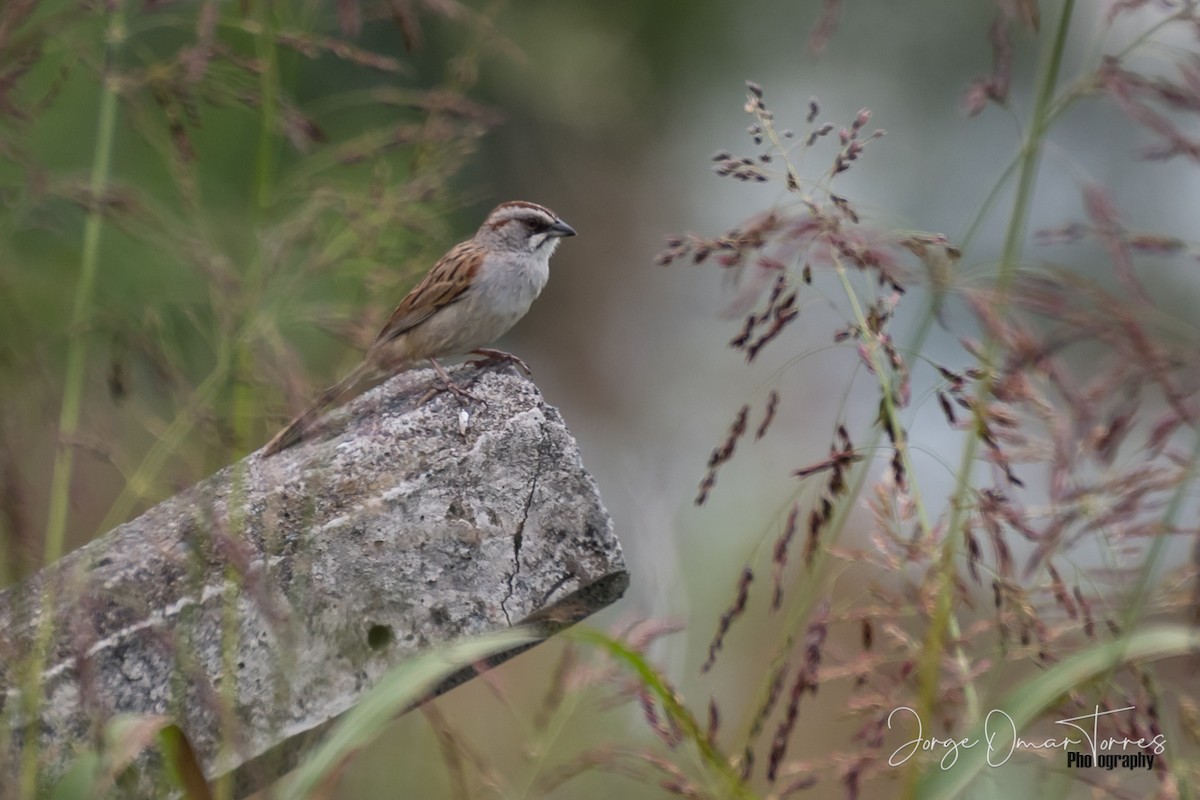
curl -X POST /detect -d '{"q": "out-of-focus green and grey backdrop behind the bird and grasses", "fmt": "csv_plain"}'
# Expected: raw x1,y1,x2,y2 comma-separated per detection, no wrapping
0,0,1198,798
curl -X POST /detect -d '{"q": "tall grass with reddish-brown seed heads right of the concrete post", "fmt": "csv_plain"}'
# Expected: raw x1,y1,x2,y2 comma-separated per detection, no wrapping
643,0,1200,798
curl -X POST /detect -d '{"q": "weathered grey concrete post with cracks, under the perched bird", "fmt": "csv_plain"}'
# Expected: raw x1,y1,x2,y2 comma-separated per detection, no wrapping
0,367,628,788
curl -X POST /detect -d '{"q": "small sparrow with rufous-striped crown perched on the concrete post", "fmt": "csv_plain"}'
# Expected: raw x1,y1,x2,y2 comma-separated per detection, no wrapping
263,200,575,457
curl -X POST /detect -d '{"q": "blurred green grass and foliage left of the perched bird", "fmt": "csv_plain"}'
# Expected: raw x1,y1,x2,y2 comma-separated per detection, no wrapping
0,0,504,573
